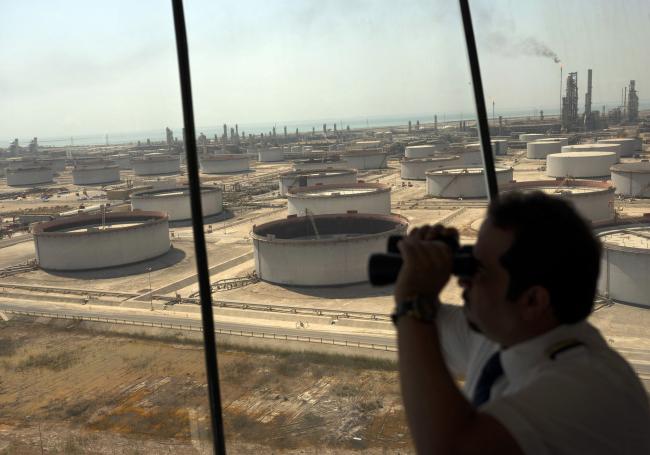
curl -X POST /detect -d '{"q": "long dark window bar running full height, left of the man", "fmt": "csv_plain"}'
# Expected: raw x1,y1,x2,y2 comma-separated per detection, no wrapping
172,0,226,455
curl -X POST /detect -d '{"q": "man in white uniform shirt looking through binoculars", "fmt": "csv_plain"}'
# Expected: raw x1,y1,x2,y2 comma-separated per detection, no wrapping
394,192,650,455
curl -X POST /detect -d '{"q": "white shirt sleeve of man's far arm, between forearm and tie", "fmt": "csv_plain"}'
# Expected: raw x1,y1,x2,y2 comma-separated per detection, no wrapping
436,304,476,378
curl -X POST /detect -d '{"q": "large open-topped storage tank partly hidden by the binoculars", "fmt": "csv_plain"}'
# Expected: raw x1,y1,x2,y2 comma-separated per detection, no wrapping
252,214,408,286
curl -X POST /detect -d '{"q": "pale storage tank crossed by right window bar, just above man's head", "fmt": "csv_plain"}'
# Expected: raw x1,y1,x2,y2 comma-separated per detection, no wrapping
426,167,512,198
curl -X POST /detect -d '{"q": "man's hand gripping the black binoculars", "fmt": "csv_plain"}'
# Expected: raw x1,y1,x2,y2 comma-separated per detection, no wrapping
394,224,458,303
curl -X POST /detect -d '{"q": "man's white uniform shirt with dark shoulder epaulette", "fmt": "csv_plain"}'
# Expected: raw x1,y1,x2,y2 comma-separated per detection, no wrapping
437,305,650,455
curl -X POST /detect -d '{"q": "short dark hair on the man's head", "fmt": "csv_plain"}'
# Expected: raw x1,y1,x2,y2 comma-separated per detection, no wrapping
488,191,601,324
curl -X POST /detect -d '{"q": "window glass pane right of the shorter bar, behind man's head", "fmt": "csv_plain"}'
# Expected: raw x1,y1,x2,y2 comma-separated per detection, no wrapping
472,1,650,389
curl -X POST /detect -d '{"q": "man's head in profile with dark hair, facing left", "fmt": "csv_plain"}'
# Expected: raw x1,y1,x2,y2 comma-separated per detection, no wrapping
460,192,600,345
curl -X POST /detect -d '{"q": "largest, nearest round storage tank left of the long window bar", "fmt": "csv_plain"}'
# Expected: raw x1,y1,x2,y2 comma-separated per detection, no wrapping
33,212,171,271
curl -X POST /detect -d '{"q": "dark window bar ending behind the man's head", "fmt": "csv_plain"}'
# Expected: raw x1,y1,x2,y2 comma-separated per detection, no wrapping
459,0,499,200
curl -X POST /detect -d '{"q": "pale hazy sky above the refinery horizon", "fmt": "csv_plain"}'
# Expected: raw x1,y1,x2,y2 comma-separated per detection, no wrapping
0,0,650,142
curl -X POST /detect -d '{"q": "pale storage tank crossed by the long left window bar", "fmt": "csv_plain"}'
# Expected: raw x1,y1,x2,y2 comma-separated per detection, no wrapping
131,186,223,221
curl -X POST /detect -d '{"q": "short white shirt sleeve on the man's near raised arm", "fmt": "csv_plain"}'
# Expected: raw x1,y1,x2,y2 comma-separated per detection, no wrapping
480,366,650,454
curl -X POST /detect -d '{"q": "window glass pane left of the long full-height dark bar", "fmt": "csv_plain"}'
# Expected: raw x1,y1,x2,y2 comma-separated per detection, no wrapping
0,1,211,454
